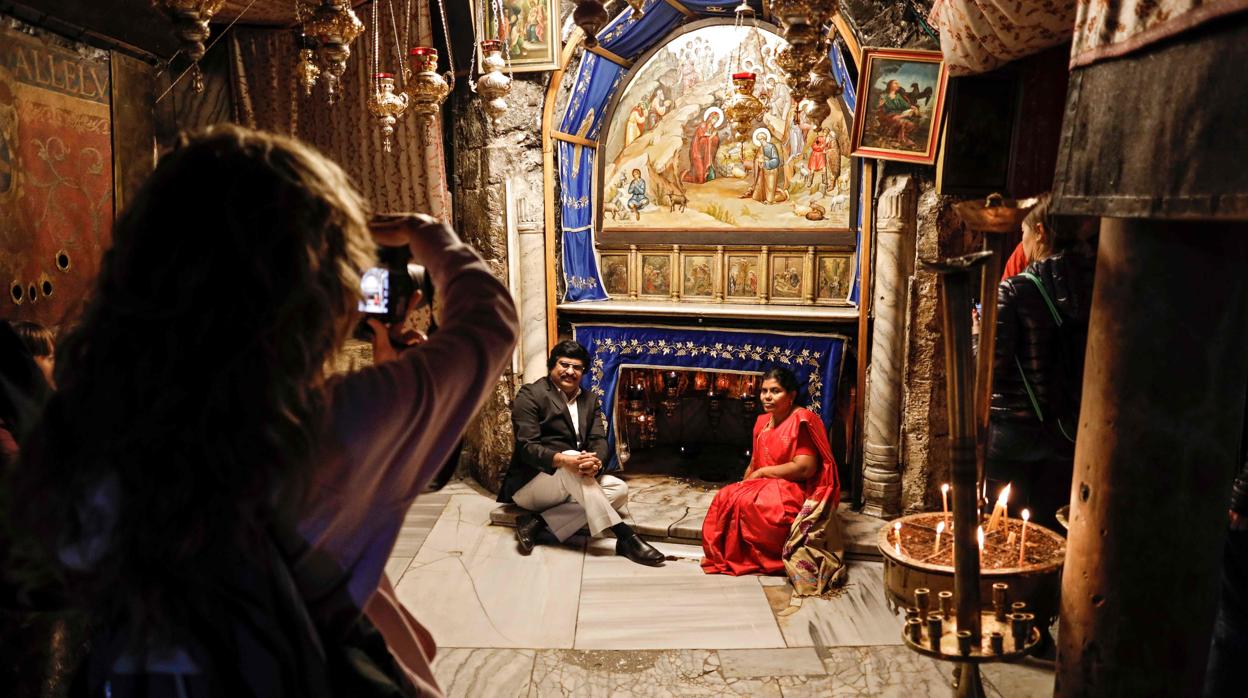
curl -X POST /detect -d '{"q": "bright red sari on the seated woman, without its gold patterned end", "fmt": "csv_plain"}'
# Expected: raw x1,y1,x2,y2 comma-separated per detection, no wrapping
701,407,841,576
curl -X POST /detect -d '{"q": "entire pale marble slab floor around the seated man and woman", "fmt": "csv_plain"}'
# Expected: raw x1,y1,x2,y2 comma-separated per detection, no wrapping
387,476,1053,698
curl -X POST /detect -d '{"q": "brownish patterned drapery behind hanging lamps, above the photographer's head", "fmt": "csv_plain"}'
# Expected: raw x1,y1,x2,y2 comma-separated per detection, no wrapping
230,5,451,219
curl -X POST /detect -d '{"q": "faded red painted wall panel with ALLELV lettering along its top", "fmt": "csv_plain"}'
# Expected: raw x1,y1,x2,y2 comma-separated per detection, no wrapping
0,26,112,325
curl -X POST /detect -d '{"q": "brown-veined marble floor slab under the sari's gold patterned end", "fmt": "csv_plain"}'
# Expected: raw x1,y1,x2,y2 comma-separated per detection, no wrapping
765,561,902,647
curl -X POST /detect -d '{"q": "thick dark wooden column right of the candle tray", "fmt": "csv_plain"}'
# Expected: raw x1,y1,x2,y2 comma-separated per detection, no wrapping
1056,219,1248,697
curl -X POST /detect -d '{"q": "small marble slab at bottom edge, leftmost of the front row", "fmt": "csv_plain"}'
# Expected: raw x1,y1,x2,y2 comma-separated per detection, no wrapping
433,648,537,698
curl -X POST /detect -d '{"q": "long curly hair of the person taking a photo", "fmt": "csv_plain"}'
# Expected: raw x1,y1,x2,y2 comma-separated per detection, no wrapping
14,125,376,636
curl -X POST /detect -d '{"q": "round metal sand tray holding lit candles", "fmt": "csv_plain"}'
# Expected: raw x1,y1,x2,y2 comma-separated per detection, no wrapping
877,512,1066,619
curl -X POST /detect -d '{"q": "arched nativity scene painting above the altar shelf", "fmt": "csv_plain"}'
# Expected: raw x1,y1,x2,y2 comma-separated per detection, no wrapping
599,25,851,234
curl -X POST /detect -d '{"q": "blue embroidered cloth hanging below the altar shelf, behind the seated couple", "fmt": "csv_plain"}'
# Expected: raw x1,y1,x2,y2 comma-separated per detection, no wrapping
572,325,845,469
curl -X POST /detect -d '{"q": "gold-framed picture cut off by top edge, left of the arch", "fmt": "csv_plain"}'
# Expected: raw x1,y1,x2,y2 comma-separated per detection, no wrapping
470,0,563,72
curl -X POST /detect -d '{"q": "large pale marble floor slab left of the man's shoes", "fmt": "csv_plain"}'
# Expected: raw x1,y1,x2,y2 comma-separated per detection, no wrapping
396,493,584,648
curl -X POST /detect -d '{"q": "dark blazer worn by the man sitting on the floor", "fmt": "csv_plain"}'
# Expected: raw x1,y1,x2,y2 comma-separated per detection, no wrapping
498,377,608,502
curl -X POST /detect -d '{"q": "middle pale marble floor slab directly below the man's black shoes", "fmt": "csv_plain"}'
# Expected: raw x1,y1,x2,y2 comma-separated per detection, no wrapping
575,542,785,649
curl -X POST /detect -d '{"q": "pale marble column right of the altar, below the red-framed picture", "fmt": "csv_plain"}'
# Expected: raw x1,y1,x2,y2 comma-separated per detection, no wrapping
862,175,919,517
